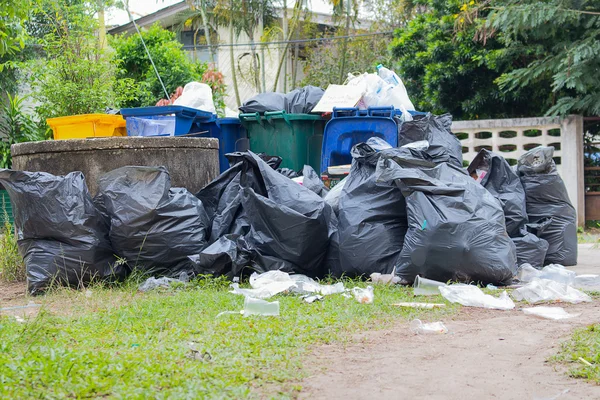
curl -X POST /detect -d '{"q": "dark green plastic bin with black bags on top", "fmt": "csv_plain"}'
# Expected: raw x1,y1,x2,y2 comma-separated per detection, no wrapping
240,111,325,172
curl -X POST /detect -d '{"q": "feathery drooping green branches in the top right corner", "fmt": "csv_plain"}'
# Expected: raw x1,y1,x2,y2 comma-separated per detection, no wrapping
472,0,600,115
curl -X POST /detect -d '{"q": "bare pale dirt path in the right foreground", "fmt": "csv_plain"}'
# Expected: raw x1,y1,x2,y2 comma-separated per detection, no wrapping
299,245,600,400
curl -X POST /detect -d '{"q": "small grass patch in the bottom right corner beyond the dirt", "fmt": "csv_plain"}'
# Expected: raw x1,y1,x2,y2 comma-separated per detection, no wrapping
554,324,600,384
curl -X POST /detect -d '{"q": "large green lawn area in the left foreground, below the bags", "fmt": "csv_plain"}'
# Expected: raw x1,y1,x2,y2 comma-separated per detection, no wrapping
0,278,458,399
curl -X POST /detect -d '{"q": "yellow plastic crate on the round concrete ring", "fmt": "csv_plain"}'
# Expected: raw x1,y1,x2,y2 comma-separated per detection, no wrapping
46,114,127,140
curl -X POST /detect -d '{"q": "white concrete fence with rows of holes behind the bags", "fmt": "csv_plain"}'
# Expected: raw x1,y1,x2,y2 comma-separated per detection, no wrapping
452,115,585,226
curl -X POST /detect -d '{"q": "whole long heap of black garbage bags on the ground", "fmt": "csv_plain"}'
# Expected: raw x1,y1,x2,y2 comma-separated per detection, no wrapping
0,114,577,294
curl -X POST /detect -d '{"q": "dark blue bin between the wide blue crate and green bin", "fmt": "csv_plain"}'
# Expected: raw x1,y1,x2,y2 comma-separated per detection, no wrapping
197,114,249,172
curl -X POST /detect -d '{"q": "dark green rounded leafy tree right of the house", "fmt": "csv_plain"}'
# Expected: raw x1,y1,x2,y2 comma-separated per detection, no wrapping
391,0,552,119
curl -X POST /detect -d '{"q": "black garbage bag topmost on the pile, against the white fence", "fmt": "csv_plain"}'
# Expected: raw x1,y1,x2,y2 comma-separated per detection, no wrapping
398,113,463,168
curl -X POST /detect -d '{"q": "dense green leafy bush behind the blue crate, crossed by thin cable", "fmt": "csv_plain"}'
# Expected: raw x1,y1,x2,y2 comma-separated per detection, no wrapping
110,23,207,107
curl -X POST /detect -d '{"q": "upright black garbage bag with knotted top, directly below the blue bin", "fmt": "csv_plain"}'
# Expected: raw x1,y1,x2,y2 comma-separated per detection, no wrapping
330,143,434,277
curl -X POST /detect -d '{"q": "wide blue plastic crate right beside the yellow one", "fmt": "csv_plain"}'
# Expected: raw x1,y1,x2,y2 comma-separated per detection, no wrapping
121,106,213,136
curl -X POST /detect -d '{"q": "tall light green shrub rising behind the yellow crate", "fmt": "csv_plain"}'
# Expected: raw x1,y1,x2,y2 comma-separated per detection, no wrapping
31,0,135,120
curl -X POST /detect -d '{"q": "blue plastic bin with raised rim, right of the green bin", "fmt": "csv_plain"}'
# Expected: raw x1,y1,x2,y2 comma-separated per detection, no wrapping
320,107,400,173
